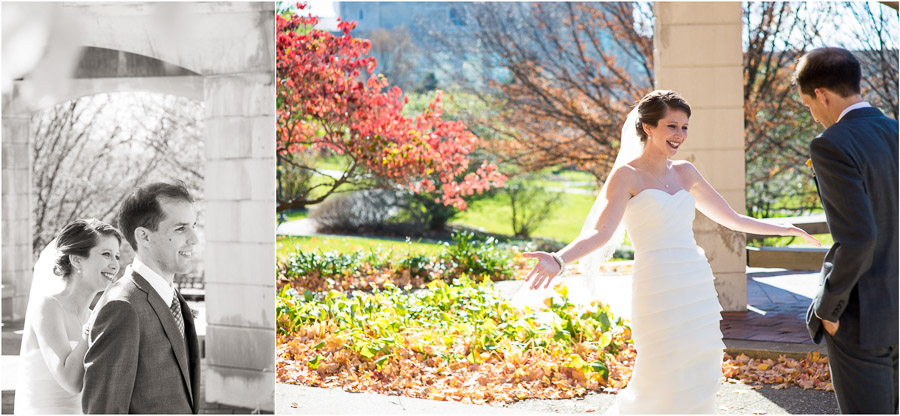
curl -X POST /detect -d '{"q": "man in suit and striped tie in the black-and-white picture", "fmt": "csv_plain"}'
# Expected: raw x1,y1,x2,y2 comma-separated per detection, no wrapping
82,183,200,414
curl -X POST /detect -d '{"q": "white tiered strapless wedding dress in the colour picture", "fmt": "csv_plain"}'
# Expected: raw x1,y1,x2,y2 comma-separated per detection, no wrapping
611,189,725,414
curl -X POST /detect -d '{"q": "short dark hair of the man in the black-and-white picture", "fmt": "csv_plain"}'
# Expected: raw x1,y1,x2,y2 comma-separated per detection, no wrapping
117,181,194,251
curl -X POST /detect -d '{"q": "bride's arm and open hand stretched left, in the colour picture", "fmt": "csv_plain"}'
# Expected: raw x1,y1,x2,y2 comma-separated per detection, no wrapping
524,168,635,289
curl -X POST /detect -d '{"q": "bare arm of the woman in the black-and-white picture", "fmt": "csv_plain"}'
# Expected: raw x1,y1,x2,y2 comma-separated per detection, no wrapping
33,297,88,394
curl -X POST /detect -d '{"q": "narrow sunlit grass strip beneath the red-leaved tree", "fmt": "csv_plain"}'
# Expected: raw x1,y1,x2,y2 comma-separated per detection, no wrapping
275,235,444,259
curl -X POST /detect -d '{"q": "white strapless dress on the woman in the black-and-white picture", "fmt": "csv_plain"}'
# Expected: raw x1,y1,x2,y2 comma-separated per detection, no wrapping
13,341,82,415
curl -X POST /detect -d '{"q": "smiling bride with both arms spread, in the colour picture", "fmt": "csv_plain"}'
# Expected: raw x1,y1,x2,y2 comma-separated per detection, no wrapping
525,91,820,414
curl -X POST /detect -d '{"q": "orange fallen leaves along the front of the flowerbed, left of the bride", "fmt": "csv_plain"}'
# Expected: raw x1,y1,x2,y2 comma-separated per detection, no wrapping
276,324,635,404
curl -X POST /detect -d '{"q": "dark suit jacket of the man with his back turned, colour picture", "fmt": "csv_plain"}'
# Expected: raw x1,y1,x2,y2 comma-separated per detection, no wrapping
807,107,900,348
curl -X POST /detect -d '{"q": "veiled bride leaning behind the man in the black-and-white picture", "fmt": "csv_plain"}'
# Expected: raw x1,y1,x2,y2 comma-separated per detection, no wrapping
14,219,122,414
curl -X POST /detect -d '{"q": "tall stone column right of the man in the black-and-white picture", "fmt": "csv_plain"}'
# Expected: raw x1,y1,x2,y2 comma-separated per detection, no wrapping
200,4,275,411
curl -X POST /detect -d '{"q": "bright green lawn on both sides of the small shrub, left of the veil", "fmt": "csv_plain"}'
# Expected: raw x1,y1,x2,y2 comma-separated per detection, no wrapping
453,194,594,243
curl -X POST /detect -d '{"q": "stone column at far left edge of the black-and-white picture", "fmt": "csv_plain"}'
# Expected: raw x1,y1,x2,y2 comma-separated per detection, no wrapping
2,88,34,321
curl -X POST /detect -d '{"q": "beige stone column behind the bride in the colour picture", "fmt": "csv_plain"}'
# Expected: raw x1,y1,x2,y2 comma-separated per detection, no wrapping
653,2,747,311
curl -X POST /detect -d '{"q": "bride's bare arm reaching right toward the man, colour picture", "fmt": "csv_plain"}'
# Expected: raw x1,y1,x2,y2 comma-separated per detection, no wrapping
679,162,822,246
